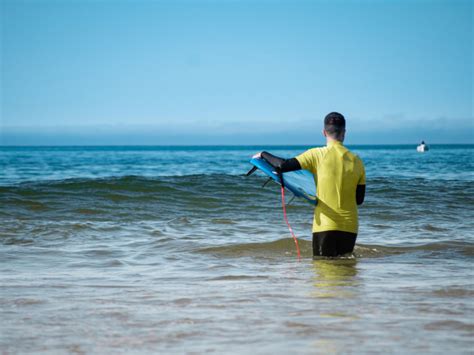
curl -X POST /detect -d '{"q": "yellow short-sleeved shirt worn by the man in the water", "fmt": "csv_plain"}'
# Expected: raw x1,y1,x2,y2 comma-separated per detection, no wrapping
296,141,365,233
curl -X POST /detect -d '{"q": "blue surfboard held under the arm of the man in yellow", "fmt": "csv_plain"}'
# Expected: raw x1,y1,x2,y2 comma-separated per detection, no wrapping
247,158,318,205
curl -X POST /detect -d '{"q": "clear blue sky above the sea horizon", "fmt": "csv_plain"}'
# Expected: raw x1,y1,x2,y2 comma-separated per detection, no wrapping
0,0,474,145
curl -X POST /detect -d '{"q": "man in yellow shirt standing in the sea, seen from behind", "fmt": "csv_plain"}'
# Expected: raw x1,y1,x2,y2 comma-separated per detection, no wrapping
254,112,365,256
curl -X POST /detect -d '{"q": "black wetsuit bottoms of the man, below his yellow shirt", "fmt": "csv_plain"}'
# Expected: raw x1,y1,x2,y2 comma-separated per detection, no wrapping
313,231,357,256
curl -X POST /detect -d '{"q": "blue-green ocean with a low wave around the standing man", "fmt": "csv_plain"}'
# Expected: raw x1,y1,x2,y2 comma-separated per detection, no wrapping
0,145,474,354
